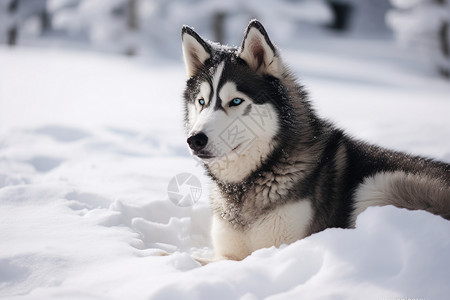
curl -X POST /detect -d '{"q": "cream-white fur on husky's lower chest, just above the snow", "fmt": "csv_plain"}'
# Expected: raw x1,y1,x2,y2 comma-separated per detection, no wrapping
212,200,312,260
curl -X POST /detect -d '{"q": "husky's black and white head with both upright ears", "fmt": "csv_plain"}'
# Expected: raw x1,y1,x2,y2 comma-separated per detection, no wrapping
182,20,285,183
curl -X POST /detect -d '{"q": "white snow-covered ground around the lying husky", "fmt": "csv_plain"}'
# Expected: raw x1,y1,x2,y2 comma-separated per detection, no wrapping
0,40,450,300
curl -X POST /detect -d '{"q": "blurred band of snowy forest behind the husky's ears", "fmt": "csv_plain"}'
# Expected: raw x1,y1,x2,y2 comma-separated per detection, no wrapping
0,0,450,79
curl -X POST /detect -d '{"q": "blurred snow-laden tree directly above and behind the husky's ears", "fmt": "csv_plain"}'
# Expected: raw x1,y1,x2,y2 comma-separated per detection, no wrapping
163,0,333,44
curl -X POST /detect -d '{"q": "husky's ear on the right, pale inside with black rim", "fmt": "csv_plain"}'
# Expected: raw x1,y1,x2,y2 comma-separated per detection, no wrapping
239,20,280,76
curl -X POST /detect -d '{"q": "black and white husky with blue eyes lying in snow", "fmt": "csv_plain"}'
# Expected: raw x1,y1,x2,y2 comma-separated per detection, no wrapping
182,20,450,260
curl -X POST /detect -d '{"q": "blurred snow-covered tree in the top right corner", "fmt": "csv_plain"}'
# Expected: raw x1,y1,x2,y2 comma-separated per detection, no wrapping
386,0,450,78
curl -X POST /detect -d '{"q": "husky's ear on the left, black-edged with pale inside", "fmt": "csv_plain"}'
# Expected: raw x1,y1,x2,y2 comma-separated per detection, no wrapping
181,25,211,77
